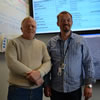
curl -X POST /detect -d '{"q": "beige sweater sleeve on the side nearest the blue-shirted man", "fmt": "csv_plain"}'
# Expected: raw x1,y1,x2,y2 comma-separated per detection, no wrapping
39,43,51,77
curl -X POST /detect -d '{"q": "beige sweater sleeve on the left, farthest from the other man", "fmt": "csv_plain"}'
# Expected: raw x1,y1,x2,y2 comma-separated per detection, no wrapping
5,40,32,76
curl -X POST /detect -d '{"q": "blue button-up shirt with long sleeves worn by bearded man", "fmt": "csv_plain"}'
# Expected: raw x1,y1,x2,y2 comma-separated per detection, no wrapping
48,33,94,92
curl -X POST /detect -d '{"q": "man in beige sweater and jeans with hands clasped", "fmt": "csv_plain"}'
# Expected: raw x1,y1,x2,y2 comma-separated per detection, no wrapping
5,16,51,100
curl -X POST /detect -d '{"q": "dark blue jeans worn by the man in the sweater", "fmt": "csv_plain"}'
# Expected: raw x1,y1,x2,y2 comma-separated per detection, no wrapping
8,86,43,100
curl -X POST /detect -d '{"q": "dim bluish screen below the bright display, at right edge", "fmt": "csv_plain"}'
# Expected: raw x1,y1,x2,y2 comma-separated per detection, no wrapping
84,34,100,79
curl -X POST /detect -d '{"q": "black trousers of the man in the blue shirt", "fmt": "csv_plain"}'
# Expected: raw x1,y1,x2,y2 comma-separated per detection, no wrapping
51,88,82,100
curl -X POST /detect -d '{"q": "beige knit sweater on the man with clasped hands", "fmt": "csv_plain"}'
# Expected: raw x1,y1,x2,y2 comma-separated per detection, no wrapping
5,36,51,87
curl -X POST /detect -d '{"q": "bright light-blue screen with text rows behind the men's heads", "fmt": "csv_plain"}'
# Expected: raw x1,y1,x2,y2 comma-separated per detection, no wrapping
33,0,100,33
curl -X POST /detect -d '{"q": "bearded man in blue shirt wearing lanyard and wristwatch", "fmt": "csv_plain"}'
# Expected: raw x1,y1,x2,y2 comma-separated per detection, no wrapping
44,11,94,100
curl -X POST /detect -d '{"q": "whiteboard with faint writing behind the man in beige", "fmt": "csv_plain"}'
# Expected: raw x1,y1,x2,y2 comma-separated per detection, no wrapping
0,0,29,35
